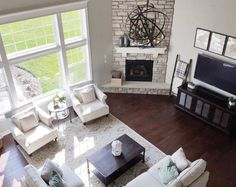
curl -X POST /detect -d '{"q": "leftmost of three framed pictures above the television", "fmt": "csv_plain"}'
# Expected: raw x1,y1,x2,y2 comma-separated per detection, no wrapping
194,28,211,50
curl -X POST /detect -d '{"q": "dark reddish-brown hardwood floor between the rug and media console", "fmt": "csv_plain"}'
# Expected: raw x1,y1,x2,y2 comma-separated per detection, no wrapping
108,94,236,187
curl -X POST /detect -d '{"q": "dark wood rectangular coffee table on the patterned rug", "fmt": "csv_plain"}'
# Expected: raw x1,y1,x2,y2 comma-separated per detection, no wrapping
87,134,145,185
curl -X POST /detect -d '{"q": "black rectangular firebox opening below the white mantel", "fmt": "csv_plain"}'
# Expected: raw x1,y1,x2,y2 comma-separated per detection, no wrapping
125,60,153,82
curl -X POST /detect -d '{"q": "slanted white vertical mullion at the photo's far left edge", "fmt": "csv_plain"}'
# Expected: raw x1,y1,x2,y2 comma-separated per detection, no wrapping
0,34,17,107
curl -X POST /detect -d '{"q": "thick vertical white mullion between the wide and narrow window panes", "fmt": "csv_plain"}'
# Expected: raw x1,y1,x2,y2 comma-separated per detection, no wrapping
54,14,69,90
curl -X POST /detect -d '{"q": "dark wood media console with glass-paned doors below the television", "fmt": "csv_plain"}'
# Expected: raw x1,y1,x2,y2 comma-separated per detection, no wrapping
176,84,236,134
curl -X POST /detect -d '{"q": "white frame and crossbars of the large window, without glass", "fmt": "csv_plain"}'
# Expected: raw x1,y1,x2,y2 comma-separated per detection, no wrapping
0,1,93,108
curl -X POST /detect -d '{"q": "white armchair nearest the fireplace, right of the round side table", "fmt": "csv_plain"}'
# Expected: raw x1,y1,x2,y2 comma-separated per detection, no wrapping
71,84,109,124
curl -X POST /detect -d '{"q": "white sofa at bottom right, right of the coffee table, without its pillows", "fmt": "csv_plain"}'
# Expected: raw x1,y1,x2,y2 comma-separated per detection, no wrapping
126,154,209,187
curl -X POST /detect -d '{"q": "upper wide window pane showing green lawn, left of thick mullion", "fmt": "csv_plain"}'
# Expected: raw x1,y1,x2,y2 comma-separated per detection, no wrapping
0,16,55,54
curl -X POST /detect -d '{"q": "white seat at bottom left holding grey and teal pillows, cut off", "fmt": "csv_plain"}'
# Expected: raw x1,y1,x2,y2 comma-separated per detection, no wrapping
21,164,84,187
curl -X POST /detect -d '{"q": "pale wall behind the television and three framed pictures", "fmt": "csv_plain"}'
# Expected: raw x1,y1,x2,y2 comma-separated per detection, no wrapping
166,0,236,96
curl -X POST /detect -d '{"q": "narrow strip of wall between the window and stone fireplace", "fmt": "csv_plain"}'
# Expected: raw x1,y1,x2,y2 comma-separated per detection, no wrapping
88,0,112,85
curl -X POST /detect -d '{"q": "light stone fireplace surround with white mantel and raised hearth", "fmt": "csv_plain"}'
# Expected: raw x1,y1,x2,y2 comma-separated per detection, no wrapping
100,0,175,94
